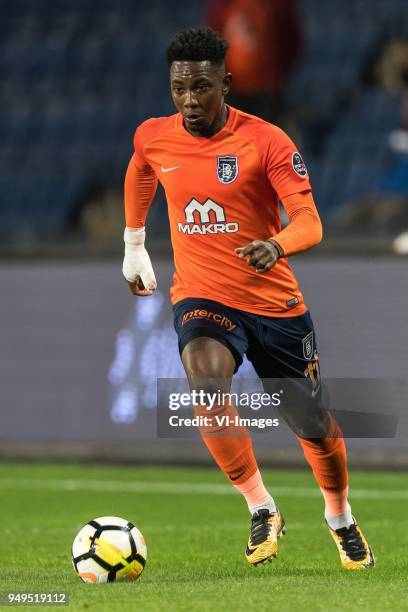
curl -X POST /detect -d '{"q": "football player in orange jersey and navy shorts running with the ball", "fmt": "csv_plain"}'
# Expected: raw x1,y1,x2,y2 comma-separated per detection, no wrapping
123,27,374,570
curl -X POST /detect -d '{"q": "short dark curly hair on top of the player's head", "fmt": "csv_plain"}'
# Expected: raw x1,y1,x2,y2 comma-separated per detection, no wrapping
166,27,228,66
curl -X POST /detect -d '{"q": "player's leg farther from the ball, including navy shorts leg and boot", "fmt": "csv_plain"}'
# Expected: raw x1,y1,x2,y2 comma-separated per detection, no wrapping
247,313,374,569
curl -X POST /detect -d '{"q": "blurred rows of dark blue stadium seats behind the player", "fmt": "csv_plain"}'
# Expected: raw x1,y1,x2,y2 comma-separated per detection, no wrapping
0,0,408,240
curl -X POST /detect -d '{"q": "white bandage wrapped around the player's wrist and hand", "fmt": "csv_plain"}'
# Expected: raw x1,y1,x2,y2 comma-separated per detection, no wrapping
122,227,157,291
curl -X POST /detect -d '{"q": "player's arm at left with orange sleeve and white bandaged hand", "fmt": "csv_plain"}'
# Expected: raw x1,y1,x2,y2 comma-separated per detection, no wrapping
122,123,157,296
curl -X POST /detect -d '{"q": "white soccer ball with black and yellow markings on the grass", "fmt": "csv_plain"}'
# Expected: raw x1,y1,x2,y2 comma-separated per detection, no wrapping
72,516,147,583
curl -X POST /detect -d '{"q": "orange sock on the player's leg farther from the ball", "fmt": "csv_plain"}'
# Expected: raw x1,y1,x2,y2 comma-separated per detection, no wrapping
297,415,349,516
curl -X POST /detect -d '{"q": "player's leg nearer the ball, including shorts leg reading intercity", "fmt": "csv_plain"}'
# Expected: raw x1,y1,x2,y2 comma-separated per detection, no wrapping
174,299,283,563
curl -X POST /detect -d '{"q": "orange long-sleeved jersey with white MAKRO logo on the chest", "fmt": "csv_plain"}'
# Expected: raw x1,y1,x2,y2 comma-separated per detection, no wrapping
125,107,321,317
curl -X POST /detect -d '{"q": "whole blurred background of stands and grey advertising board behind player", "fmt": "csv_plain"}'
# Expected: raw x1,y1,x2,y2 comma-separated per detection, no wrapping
0,0,408,468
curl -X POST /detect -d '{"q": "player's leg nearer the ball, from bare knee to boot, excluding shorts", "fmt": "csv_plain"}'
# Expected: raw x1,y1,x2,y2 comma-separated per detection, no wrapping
181,337,284,565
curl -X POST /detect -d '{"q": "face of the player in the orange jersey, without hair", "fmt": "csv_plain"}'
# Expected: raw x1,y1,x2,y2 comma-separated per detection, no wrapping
170,61,231,136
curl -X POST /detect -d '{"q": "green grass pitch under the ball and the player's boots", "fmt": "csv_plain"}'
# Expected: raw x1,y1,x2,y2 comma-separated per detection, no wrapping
0,464,408,612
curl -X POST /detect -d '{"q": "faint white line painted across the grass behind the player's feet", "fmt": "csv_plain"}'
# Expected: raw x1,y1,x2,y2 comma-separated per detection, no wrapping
0,478,408,500
